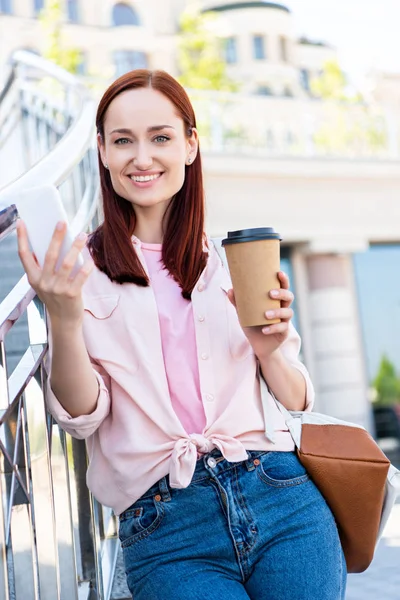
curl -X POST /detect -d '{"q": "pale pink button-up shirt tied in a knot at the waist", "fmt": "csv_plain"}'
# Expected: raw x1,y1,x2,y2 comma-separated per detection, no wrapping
47,238,313,515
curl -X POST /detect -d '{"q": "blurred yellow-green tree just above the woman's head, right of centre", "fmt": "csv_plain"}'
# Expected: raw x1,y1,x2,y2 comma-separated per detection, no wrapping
178,6,238,92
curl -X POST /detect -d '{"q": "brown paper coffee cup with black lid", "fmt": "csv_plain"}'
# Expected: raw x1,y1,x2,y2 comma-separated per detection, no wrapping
222,227,281,327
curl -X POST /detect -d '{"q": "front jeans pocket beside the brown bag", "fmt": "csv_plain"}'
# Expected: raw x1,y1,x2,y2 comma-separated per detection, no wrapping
257,452,310,487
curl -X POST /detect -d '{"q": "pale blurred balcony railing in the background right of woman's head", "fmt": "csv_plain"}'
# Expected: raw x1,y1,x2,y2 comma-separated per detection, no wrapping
188,90,400,160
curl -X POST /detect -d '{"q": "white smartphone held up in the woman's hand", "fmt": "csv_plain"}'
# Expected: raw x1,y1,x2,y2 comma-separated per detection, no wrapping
10,185,83,274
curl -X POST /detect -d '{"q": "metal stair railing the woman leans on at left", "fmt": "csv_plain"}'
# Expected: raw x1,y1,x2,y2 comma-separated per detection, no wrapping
0,52,118,600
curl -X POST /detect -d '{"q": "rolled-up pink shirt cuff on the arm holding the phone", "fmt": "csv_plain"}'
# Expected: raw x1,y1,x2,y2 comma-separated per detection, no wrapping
45,322,111,440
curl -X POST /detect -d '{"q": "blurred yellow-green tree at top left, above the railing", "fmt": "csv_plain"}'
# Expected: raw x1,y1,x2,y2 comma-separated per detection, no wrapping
39,0,82,73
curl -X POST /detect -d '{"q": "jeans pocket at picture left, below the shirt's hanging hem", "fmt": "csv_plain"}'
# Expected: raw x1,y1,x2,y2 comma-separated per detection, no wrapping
118,497,164,548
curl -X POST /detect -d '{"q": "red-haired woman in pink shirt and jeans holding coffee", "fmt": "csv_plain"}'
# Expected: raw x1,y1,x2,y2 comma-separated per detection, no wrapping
18,70,346,600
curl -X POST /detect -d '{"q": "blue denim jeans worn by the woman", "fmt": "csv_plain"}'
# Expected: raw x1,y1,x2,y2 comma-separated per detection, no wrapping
119,450,346,600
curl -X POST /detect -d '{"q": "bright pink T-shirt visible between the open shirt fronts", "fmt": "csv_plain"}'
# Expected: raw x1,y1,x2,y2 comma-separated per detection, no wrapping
141,242,206,434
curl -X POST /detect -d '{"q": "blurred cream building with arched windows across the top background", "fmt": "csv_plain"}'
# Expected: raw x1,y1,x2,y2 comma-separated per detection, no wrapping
0,0,335,97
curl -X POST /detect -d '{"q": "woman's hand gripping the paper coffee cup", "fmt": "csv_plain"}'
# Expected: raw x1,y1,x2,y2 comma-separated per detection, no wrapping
228,271,294,360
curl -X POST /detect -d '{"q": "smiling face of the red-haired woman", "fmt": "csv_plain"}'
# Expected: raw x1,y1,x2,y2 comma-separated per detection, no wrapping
98,88,198,211
